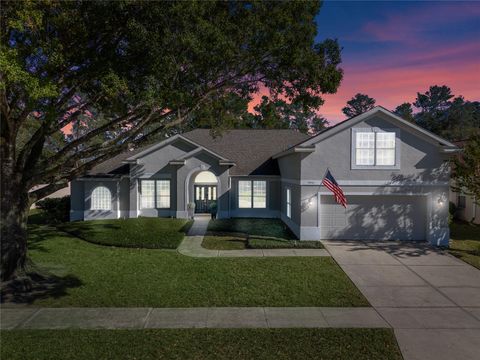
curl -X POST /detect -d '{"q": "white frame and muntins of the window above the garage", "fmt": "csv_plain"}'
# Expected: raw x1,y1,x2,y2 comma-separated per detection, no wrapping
351,127,400,170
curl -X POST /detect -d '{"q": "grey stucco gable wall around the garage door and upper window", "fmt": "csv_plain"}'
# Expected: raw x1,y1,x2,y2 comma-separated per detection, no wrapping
291,115,450,245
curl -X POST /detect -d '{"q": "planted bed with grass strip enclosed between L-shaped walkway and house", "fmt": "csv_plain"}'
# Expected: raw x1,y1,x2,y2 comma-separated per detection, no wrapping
202,218,323,250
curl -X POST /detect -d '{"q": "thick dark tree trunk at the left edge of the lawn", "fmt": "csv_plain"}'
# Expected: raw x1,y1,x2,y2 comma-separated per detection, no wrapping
0,169,30,281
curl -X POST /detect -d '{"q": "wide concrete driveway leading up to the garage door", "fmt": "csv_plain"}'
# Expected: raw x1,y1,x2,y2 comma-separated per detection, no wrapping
323,241,480,360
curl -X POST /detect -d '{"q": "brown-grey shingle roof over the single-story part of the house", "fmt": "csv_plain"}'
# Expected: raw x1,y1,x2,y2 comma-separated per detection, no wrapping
89,129,310,176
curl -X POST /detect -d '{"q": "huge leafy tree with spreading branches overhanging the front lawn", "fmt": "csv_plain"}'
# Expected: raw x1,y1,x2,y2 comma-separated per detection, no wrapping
0,0,342,279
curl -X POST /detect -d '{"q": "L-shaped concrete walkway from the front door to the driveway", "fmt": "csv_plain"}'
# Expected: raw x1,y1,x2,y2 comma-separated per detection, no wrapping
177,215,330,257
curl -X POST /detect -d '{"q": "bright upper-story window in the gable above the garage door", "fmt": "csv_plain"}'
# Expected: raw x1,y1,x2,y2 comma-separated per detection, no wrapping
352,129,399,169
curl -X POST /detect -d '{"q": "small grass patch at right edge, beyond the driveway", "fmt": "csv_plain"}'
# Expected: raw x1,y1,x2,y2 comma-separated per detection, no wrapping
449,222,480,269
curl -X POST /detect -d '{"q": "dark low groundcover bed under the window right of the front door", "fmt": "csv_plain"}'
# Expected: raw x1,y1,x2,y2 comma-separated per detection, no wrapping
208,218,295,240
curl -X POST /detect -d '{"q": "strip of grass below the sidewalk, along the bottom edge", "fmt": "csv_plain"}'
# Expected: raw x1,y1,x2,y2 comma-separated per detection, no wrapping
1,329,402,360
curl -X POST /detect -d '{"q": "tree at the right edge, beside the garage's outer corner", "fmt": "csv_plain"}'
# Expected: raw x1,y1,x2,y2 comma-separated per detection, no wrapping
452,132,480,204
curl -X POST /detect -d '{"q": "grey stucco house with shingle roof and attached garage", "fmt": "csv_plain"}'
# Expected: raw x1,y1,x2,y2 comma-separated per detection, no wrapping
71,107,458,245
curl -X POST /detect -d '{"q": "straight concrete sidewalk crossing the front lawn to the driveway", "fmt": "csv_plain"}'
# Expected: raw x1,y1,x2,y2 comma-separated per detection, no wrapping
0,307,389,329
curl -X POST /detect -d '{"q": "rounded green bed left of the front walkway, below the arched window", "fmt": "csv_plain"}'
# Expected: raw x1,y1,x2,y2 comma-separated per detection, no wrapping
58,218,192,249
